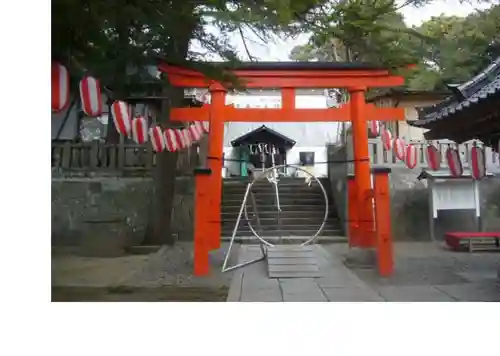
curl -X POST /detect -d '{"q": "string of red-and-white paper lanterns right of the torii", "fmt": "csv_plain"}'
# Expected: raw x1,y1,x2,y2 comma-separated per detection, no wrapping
368,121,486,180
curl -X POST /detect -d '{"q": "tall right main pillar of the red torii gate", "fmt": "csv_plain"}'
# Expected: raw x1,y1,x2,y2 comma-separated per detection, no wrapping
349,87,375,248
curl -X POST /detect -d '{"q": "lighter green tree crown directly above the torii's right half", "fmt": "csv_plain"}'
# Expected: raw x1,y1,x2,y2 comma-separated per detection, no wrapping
291,0,428,67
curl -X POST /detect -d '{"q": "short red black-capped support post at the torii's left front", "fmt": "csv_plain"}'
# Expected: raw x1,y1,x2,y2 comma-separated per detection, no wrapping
193,168,212,276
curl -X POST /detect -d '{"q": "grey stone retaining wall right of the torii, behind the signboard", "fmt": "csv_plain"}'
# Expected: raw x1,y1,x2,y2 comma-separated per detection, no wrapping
328,146,500,241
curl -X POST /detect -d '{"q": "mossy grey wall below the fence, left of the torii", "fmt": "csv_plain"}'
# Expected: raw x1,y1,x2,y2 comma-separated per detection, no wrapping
51,177,193,249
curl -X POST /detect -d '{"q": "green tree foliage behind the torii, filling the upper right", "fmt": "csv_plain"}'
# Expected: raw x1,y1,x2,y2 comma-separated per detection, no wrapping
290,0,500,90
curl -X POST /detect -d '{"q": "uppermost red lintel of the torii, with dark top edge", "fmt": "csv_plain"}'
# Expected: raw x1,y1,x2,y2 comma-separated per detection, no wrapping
158,62,404,89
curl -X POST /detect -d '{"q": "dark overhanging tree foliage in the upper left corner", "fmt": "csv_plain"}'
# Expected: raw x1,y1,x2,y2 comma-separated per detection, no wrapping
52,0,321,96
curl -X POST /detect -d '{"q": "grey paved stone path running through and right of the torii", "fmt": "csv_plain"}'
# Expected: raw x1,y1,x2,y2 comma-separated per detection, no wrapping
227,244,500,302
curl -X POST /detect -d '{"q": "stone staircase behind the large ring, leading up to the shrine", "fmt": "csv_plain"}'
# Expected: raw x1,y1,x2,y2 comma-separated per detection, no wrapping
221,177,346,243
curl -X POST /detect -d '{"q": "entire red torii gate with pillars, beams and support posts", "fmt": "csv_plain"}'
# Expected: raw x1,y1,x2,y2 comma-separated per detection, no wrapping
158,62,404,275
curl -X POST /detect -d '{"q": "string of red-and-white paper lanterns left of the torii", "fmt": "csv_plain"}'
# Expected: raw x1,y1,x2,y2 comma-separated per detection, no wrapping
51,62,210,152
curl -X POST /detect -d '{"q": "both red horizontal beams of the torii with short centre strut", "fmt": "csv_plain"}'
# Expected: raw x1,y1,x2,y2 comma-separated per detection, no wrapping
158,62,404,122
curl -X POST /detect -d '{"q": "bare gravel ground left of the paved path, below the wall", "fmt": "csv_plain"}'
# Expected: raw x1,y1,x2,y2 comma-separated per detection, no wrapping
52,242,237,301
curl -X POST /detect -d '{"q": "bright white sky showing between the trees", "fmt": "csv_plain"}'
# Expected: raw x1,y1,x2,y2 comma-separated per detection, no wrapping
229,0,490,61
